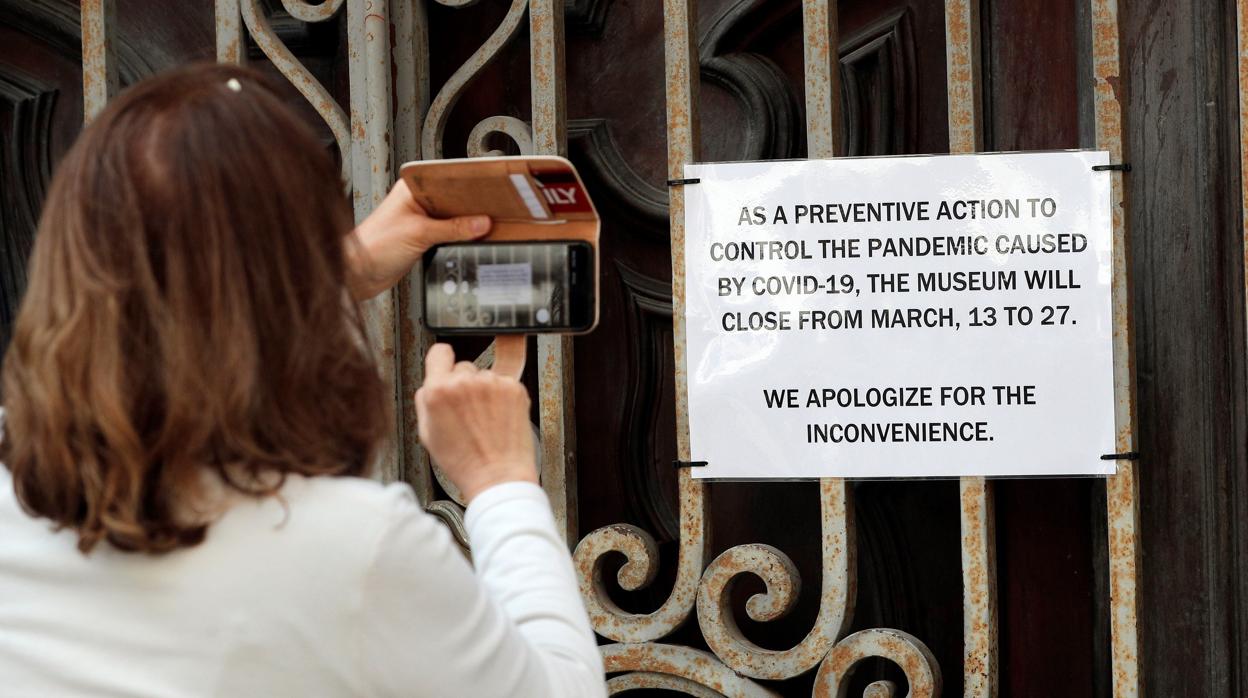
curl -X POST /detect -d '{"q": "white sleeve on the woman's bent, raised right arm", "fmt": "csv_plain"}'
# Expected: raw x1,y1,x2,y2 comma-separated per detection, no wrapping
359,482,607,698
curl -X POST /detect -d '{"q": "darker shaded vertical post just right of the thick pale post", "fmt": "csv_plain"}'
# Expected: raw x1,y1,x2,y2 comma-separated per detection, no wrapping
389,0,434,504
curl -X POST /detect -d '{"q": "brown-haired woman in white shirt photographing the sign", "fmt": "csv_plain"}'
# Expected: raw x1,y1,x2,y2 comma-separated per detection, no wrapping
0,66,605,698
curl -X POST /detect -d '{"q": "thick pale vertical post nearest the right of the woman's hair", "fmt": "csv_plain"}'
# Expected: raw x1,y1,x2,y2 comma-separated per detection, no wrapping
347,0,403,481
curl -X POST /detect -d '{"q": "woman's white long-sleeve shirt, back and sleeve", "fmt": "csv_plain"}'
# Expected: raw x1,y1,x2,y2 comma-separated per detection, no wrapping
0,467,607,698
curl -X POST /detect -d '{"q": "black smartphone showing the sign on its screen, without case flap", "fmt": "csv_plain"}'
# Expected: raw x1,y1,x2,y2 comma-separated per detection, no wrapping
423,240,598,335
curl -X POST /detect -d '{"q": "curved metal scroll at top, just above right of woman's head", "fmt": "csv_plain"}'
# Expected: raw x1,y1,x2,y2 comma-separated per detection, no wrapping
240,0,351,182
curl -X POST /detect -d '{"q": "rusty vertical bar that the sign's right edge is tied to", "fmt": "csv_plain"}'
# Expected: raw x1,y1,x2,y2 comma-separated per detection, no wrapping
1092,0,1143,698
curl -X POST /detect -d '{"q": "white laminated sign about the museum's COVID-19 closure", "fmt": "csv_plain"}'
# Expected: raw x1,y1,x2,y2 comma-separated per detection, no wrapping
685,151,1116,478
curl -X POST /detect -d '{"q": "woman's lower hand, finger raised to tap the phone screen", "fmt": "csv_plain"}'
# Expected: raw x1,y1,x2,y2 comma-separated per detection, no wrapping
416,345,538,503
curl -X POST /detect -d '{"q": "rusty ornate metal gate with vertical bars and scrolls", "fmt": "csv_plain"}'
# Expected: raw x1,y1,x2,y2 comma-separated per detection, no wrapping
81,0,1143,697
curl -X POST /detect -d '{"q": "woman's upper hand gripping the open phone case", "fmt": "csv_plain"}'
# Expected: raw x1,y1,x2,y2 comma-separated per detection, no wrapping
347,180,490,301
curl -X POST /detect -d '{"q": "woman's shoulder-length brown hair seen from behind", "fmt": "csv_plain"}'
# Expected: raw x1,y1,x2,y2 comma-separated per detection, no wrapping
0,65,389,552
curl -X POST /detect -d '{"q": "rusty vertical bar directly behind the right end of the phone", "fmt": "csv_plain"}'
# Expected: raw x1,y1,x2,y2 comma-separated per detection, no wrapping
529,0,577,544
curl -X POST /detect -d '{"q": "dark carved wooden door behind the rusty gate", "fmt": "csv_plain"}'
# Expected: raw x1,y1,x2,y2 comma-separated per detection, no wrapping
0,0,1248,697
